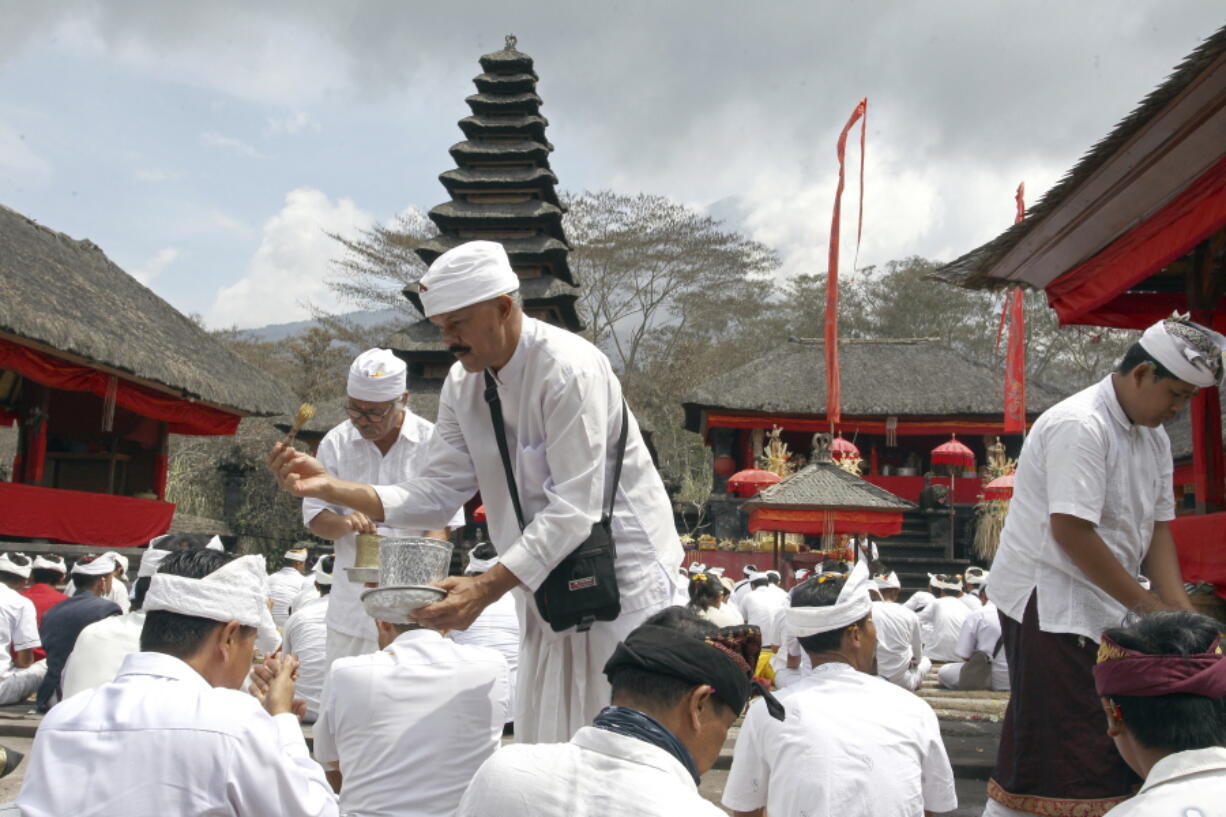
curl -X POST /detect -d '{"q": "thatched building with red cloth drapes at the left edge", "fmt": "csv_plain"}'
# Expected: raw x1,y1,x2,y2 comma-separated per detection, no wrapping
0,206,294,550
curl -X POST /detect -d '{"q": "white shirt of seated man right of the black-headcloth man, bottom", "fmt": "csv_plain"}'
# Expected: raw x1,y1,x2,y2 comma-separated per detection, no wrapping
723,662,958,817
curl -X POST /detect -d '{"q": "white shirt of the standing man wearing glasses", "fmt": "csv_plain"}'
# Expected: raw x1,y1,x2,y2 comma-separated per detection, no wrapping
303,410,472,642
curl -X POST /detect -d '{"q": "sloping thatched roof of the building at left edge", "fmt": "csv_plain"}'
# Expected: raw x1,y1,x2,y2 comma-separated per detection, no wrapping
0,206,293,416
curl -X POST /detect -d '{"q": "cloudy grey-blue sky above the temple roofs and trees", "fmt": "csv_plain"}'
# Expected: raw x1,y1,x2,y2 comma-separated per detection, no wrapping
0,0,1226,326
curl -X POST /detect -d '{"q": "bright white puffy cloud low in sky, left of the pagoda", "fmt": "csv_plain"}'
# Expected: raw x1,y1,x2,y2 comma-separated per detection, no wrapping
206,188,374,328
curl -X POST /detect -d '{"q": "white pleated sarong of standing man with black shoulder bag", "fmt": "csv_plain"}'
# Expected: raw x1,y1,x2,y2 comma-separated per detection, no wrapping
515,602,667,743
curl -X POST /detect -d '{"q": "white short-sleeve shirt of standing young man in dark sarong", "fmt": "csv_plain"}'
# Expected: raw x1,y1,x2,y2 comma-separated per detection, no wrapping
988,375,1175,642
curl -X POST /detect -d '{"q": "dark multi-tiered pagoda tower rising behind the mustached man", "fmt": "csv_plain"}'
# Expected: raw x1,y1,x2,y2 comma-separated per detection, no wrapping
390,36,582,391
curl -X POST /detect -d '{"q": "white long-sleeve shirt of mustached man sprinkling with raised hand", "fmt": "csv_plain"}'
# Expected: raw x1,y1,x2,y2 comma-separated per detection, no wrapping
375,316,683,625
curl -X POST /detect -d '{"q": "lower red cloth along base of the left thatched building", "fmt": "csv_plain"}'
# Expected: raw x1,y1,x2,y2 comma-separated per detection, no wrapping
0,482,174,547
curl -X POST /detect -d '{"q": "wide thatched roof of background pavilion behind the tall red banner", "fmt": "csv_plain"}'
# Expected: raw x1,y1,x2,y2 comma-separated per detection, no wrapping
682,337,1065,432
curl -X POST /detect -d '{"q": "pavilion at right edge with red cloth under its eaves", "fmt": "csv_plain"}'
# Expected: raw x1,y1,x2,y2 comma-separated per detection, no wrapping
933,27,1226,588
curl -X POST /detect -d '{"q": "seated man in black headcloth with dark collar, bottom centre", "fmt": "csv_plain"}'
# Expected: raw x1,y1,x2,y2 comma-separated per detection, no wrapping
459,607,782,817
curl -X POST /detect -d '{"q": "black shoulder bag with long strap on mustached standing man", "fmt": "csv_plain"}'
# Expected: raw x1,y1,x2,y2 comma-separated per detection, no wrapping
485,370,629,633
